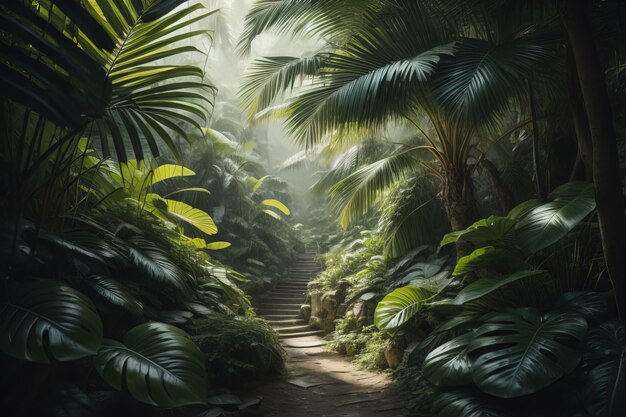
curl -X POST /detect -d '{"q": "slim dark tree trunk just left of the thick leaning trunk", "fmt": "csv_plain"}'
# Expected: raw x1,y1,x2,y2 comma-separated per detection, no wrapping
567,47,593,181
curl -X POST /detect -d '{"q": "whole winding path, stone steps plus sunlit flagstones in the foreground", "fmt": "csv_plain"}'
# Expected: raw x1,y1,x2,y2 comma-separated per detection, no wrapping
236,253,403,417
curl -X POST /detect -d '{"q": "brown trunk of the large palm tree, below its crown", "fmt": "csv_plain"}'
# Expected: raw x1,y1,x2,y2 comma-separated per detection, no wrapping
441,167,478,260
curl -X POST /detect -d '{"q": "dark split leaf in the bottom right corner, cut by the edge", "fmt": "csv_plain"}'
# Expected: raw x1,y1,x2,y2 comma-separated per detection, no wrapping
583,322,626,417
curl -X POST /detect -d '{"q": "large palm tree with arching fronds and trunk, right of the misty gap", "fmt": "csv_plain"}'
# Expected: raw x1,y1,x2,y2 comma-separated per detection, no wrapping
242,0,548,254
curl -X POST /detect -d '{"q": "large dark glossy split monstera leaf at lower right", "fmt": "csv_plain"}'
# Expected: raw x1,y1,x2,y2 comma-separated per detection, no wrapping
468,308,587,398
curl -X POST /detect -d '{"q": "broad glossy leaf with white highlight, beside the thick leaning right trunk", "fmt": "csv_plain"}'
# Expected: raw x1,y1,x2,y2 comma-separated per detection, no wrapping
516,182,596,253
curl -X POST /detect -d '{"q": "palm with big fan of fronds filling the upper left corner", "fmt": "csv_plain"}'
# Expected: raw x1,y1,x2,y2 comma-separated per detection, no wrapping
0,0,213,224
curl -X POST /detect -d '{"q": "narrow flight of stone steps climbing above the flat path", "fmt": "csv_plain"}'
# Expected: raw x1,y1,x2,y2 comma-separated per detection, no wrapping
257,250,324,339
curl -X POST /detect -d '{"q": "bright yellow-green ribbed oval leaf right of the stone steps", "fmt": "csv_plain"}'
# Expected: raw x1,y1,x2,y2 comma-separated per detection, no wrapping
374,286,432,329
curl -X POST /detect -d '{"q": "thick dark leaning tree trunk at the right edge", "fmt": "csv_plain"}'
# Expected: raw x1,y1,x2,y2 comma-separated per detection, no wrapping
561,0,626,319
